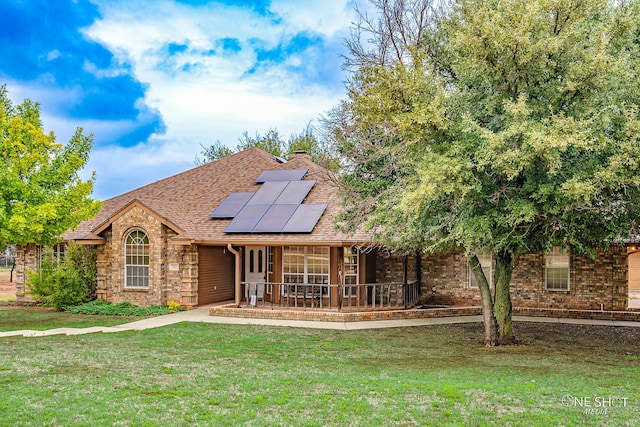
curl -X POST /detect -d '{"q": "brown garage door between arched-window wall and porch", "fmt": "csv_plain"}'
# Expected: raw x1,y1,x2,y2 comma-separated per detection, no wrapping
198,246,235,305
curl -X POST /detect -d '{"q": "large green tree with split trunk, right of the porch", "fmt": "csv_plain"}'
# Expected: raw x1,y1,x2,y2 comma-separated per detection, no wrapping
328,0,640,345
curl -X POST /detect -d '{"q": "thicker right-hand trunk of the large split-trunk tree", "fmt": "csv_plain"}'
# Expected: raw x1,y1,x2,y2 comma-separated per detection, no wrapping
493,251,517,345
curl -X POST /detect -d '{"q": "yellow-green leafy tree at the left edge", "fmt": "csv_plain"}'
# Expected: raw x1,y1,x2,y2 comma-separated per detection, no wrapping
0,85,100,248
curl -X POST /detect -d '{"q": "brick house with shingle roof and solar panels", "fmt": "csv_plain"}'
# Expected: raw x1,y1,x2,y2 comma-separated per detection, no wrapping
16,147,634,310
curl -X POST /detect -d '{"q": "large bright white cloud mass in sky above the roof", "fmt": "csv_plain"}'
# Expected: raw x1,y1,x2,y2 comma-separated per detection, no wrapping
77,0,362,197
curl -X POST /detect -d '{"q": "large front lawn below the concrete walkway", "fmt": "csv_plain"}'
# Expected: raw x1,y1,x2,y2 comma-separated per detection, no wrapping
0,323,640,426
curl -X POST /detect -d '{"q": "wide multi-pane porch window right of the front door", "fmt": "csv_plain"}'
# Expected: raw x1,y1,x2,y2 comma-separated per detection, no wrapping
282,245,331,297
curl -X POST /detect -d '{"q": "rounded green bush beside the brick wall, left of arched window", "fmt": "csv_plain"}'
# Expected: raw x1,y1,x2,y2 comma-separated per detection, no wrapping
27,244,97,309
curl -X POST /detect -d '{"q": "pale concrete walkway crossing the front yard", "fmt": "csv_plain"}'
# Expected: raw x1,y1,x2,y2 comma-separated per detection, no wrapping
0,308,640,338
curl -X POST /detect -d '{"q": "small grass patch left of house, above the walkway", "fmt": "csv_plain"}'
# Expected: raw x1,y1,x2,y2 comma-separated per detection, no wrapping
0,307,141,332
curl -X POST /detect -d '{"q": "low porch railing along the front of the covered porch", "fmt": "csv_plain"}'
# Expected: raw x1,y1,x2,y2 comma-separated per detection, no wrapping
241,281,420,311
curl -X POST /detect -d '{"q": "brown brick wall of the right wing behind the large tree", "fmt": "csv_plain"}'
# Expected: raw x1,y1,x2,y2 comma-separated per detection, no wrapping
376,246,628,310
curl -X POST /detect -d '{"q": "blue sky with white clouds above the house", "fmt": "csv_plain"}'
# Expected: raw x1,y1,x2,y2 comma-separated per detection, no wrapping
0,0,366,199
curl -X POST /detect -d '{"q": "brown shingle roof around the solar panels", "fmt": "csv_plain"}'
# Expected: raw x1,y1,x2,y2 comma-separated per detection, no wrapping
64,147,369,244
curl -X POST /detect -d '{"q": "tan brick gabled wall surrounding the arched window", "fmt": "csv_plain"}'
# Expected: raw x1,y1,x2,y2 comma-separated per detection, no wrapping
97,206,198,307
